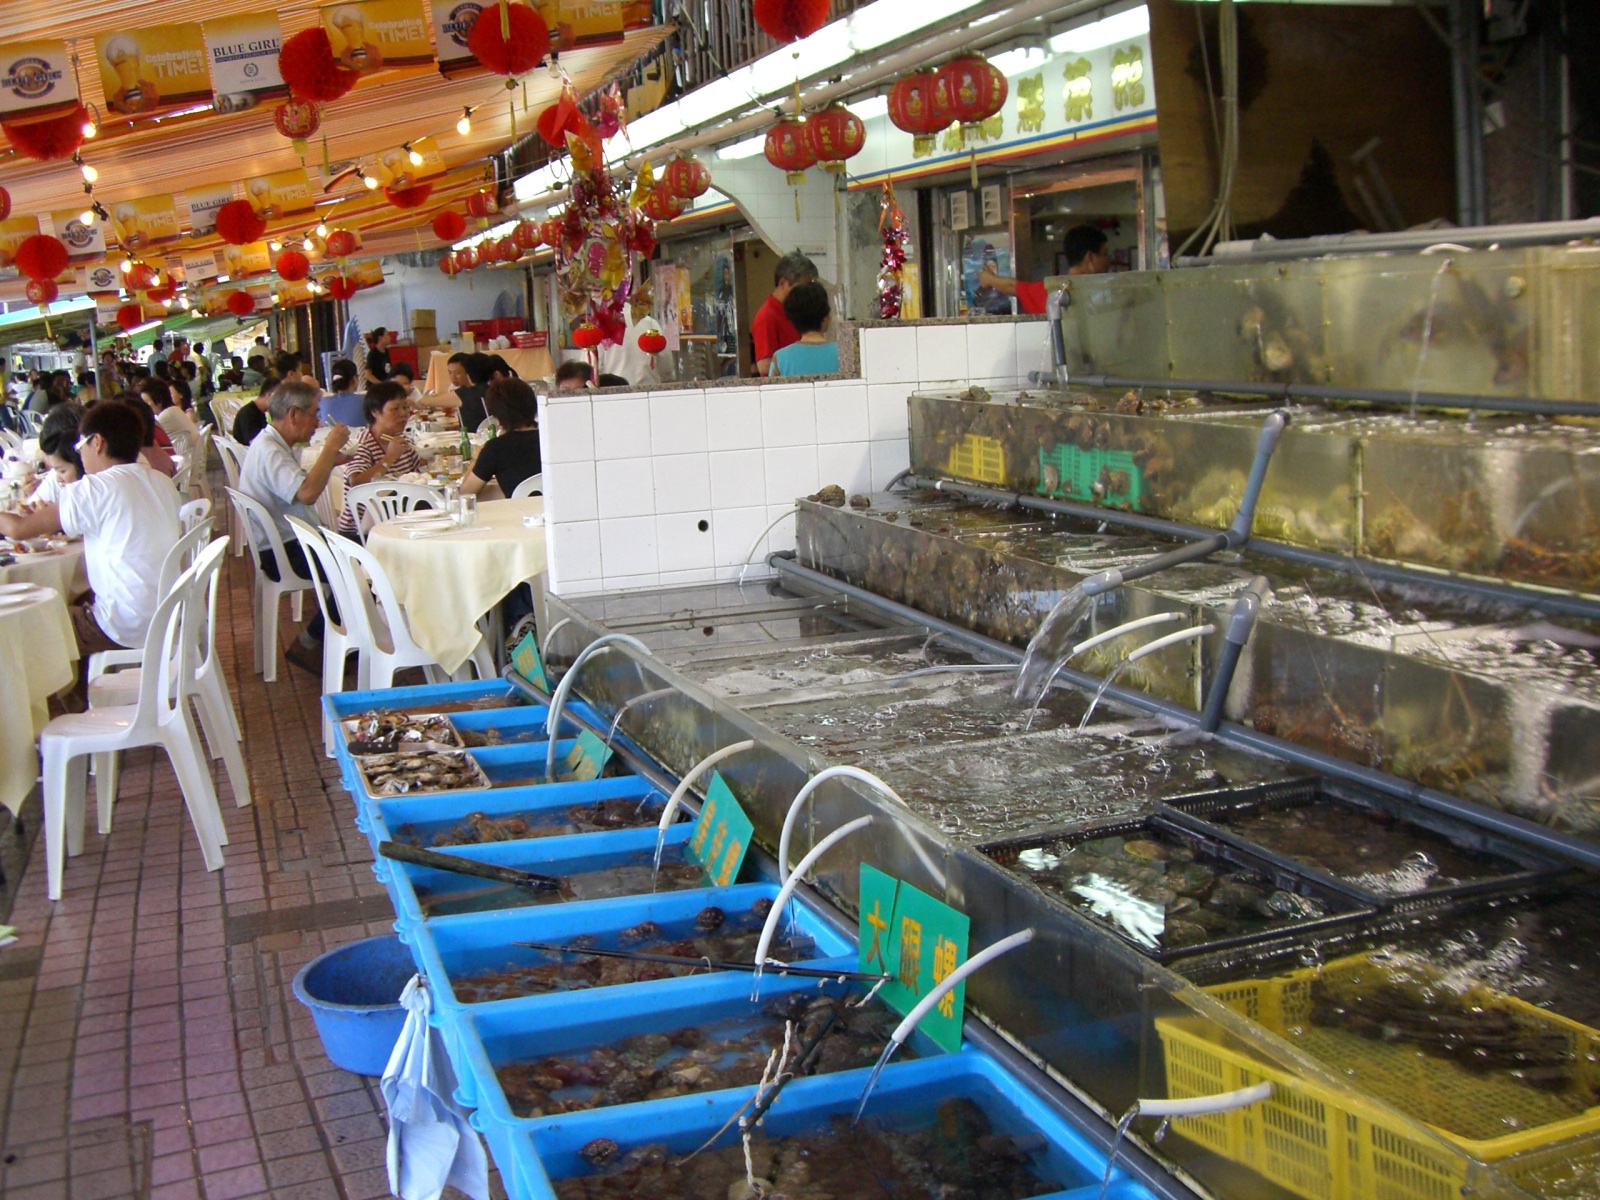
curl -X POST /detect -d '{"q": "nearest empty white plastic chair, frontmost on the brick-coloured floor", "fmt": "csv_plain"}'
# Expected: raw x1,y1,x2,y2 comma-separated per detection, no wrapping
38,542,227,901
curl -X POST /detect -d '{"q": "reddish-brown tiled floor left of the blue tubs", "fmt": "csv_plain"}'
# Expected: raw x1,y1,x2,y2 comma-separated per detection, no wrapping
0,528,502,1200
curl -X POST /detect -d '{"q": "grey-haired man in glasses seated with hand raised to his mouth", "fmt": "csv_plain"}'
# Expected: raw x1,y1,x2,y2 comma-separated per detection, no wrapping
238,379,350,675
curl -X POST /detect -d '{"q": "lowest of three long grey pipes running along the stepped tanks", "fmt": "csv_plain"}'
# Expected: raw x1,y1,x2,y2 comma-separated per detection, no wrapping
766,554,1600,867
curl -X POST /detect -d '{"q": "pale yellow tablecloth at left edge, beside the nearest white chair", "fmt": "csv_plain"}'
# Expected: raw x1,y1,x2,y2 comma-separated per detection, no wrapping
0,587,78,814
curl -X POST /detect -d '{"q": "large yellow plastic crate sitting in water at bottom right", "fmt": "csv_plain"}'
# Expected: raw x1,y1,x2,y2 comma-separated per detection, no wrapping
1155,955,1600,1200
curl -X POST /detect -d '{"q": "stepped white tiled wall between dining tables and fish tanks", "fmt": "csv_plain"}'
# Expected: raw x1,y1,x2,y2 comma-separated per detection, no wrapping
539,322,1050,595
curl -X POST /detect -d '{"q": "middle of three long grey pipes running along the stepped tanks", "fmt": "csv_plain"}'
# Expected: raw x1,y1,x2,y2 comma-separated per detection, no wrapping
906,475,1600,621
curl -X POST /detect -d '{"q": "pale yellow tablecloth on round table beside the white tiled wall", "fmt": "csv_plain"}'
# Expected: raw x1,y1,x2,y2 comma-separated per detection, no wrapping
366,496,546,672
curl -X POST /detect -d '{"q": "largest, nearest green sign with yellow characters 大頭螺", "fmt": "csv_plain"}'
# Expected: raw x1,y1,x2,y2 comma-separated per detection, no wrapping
859,862,968,1054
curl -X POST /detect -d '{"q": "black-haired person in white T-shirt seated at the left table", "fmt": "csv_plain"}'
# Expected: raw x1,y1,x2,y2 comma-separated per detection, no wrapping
0,403,182,709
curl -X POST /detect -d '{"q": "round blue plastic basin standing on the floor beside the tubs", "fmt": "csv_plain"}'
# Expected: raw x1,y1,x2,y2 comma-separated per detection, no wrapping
294,936,416,1075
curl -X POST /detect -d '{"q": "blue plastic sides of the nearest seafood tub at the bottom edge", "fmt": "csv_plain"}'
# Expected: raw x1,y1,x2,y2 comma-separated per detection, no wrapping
505,1050,1152,1200
